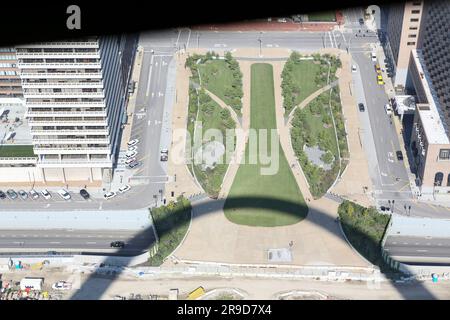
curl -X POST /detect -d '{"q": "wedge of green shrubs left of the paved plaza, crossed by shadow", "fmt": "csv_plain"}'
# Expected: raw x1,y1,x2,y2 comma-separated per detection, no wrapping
149,197,191,266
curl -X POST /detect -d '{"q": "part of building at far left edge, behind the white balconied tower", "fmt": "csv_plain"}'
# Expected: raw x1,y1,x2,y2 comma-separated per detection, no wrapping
0,48,22,98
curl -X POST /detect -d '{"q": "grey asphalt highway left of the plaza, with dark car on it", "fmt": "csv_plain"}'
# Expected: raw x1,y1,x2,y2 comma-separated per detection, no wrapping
0,230,154,255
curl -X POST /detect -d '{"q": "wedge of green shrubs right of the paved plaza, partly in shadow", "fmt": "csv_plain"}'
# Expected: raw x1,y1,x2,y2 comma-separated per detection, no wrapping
338,200,396,273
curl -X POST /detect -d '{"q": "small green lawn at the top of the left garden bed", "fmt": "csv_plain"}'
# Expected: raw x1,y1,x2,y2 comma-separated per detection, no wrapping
198,60,241,115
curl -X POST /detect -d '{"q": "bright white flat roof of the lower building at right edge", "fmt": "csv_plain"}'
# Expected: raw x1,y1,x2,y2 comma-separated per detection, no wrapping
412,50,450,144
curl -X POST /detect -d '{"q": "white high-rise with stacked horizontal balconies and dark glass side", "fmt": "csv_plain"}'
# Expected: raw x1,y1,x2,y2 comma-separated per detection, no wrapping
16,35,137,182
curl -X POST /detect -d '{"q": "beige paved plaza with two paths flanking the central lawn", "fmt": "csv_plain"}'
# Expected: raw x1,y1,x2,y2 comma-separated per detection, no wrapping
171,49,367,266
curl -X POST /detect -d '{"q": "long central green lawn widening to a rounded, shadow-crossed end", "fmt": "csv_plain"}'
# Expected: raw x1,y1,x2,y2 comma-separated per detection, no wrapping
224,63,308,227
